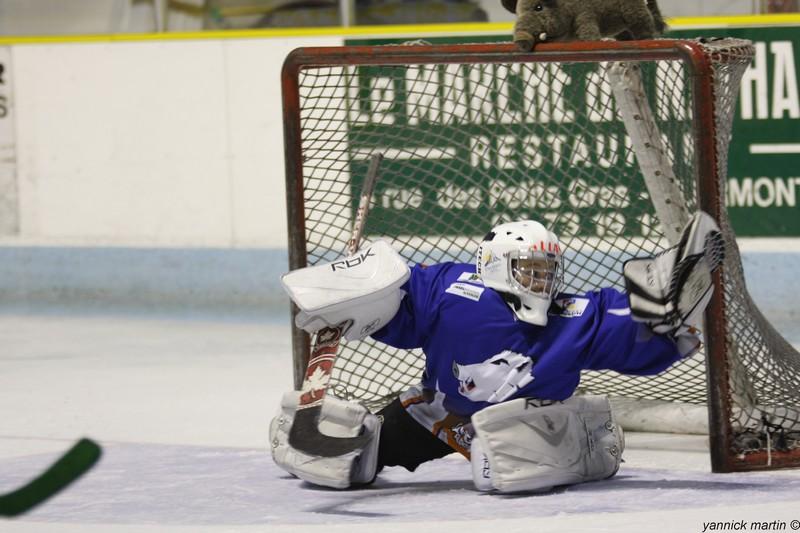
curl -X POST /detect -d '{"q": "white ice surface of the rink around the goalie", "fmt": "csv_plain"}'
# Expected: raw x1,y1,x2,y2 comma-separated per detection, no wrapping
0,312,800,533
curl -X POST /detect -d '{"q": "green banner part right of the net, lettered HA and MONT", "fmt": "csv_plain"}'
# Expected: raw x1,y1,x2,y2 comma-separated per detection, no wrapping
669,27,800,237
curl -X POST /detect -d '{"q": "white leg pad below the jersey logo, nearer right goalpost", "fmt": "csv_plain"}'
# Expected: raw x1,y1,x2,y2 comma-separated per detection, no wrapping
471,396,625,492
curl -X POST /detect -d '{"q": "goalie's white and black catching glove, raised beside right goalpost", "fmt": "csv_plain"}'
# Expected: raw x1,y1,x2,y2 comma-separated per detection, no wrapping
623,211,725,339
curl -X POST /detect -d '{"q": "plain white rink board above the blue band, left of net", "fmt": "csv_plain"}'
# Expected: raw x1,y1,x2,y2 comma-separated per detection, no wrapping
7,34,340,247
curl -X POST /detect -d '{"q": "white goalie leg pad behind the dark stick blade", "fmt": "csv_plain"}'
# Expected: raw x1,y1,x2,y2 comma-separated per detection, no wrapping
269,391,380,489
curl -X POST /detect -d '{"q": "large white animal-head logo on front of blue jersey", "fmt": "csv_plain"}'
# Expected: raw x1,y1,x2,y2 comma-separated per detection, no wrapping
453,350,533,403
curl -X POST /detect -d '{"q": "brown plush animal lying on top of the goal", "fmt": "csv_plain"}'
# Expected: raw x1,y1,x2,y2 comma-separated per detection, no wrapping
501,0,666,51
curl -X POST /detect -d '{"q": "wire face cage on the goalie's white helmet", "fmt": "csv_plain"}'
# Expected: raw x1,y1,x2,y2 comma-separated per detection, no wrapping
506,247,564,300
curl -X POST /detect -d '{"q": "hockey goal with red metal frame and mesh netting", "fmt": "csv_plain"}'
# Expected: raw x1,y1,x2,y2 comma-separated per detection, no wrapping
282,39,800,471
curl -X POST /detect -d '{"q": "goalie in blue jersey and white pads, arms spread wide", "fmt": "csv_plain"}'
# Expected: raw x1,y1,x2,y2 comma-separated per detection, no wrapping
270,212,724,493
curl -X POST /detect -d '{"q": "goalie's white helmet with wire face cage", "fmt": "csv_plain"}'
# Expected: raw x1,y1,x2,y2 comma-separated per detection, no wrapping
477,220,564,326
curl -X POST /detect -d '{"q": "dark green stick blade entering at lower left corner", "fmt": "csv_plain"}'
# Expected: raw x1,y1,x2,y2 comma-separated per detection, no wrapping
0,439,102,517
